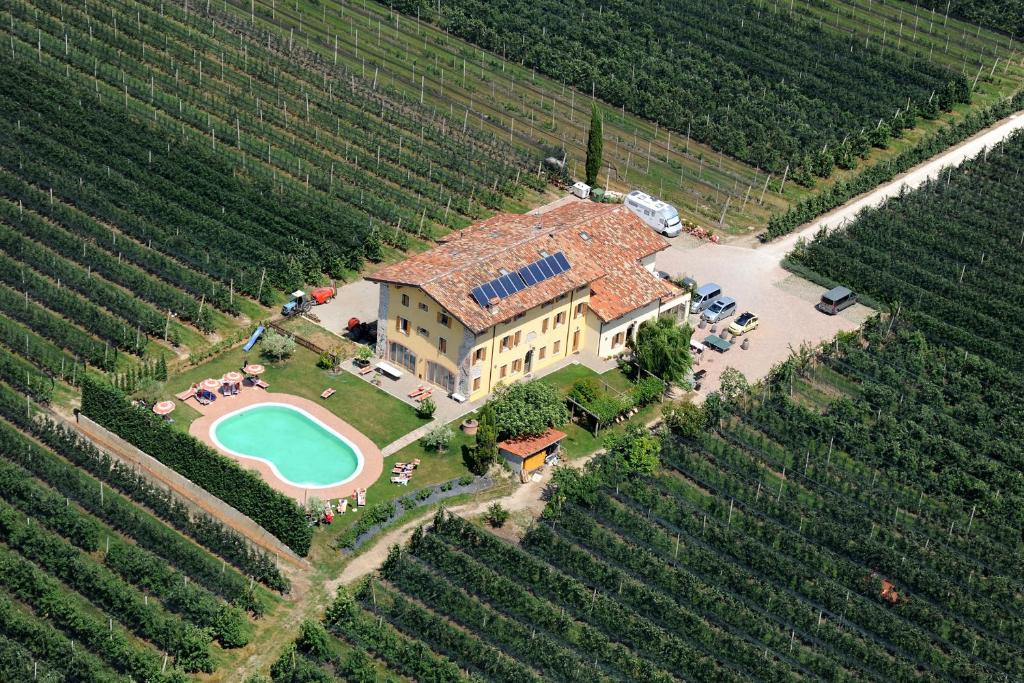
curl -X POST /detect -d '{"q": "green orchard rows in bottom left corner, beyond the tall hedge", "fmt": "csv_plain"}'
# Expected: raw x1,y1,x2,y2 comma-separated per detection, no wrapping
0,365,290,682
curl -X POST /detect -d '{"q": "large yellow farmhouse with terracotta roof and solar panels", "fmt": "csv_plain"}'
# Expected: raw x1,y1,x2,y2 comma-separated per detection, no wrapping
367,202,689,399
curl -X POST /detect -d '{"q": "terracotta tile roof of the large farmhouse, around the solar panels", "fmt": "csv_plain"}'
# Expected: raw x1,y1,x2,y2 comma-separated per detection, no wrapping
367,202,671,333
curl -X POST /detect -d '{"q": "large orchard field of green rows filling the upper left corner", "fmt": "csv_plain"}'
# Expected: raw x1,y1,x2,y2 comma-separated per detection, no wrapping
0,0,544,401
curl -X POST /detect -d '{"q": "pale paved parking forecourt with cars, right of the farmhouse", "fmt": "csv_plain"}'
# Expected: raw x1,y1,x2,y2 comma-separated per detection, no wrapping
657,236,872,396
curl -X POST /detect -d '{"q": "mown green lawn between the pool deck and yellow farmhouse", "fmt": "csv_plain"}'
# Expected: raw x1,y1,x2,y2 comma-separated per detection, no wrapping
160,346,424,447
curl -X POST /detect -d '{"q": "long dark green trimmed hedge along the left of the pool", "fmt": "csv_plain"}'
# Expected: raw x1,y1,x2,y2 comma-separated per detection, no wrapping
82,377,312,556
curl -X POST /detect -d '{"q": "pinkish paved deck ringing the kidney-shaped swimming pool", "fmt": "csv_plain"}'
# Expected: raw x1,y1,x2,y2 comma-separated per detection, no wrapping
188,386,384,503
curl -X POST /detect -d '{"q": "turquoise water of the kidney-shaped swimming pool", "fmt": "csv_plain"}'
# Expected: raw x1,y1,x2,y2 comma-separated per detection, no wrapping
211,403,362,487
